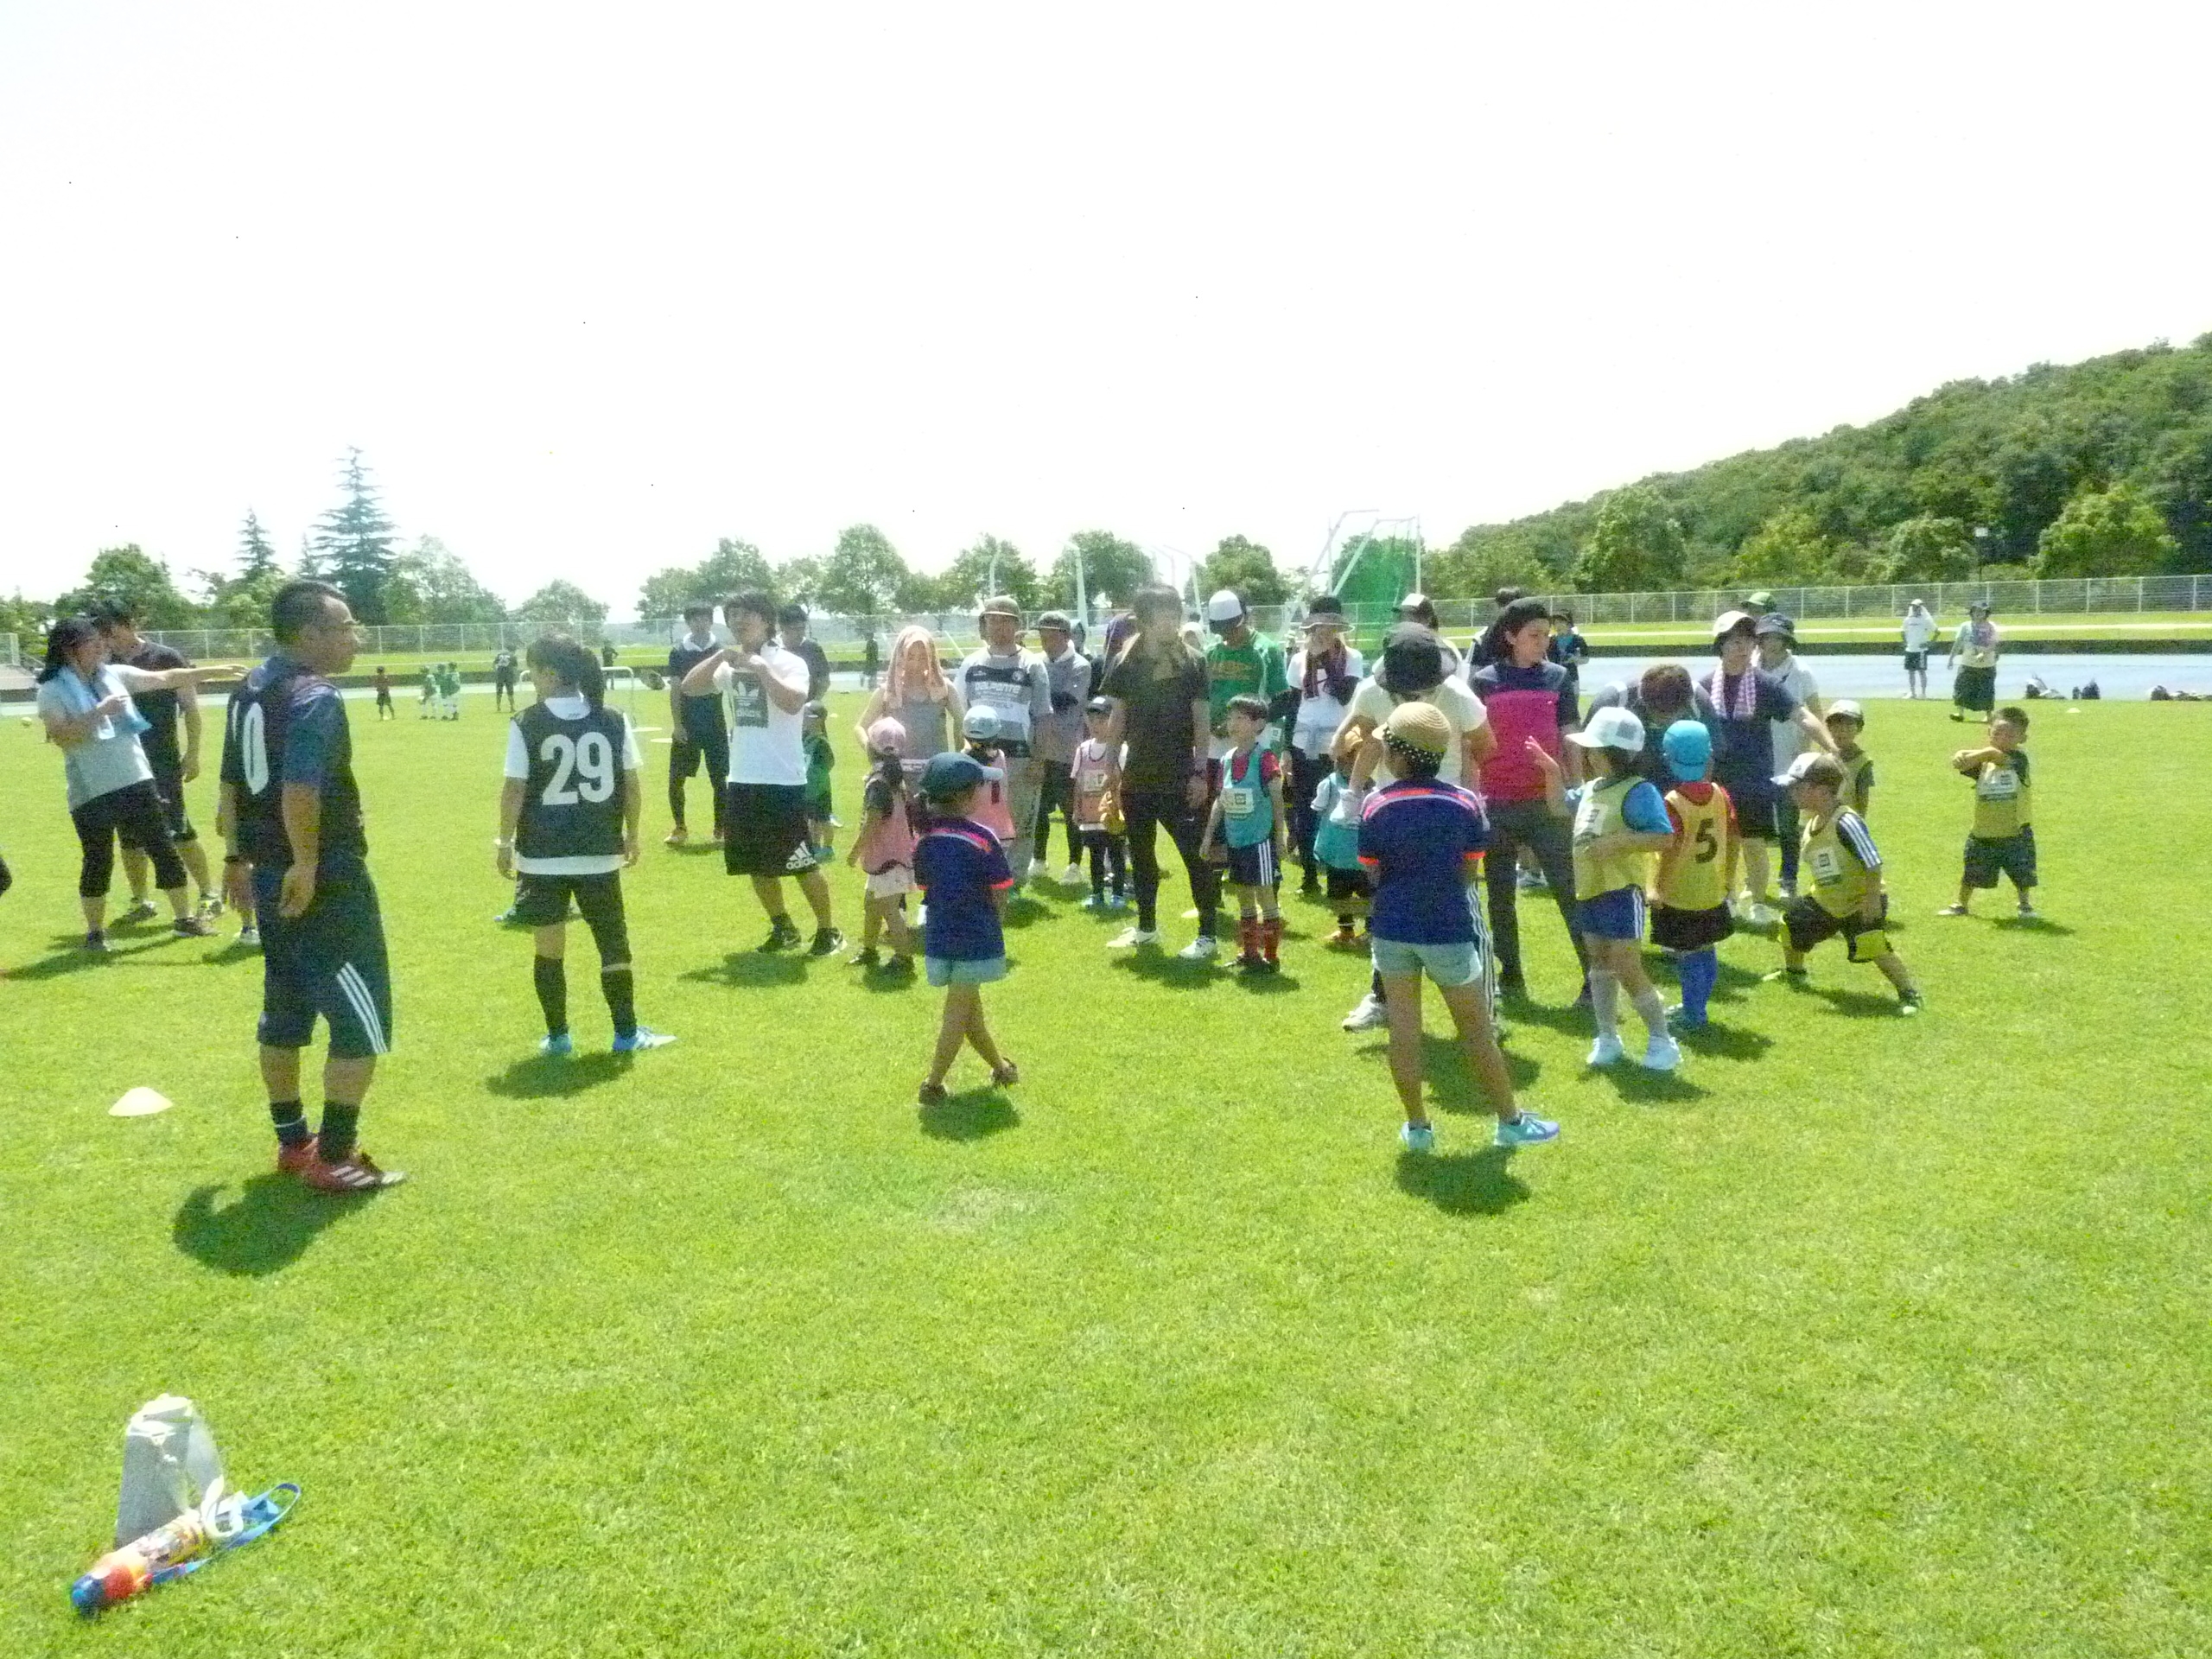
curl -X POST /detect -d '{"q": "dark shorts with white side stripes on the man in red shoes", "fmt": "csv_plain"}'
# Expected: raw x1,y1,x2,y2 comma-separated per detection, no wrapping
254,856,391,1059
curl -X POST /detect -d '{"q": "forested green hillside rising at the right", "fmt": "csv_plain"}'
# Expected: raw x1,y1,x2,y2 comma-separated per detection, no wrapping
1429,334,2212,597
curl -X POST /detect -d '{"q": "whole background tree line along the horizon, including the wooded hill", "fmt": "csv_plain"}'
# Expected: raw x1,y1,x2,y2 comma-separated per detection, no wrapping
0,334,2212,632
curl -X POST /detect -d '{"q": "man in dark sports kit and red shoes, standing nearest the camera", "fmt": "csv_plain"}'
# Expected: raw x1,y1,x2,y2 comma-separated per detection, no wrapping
224,582,407,1192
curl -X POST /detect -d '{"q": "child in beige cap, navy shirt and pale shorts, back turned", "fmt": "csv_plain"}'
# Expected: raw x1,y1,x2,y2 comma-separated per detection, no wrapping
1360,702,1560,1153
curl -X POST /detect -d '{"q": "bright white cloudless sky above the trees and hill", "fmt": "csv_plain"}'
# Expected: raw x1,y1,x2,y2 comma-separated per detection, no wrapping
0,0,2212,615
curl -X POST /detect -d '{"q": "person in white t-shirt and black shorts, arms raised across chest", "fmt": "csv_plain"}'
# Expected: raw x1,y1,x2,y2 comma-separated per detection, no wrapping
683,593,845,956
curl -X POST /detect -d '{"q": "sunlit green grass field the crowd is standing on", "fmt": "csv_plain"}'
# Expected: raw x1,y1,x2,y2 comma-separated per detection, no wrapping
0,702,2212,1659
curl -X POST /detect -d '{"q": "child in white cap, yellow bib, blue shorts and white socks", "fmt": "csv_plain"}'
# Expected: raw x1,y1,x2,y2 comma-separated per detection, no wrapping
1529,708,1681,1071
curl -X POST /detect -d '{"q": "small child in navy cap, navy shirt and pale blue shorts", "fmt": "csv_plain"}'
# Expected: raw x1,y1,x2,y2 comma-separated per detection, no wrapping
913,754,1022,1106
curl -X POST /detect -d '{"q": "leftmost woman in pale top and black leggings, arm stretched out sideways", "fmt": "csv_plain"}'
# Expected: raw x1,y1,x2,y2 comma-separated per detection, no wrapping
38,617,237,951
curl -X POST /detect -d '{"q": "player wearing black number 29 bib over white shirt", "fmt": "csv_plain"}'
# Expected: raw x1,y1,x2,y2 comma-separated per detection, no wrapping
495,635,675,1059
